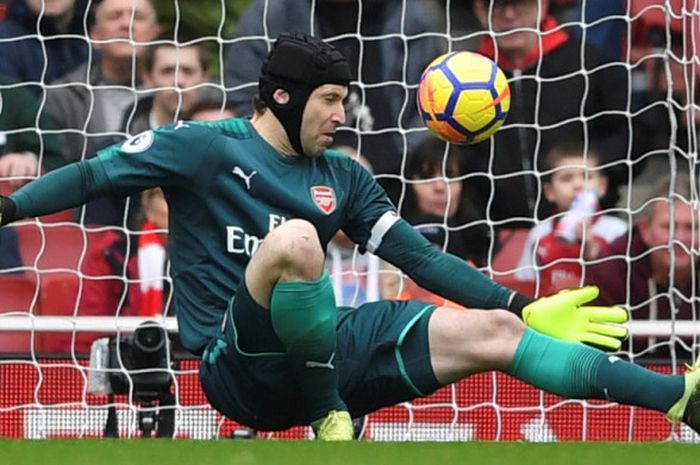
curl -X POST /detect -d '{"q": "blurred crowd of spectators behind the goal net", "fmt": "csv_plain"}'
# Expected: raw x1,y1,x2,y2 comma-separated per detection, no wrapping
0,0,700,358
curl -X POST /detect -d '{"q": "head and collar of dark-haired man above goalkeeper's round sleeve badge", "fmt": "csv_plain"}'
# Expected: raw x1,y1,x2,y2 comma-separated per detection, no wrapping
122,41,209,135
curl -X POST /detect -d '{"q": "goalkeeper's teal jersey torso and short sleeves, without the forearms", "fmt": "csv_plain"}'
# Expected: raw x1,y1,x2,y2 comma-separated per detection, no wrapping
98,119,393,352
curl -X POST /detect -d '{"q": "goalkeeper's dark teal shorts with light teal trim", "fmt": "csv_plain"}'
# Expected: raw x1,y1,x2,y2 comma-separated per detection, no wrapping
199,285,440,431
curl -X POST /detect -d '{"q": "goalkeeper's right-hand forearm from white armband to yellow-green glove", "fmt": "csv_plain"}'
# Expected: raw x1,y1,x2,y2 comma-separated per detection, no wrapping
374,213,627,349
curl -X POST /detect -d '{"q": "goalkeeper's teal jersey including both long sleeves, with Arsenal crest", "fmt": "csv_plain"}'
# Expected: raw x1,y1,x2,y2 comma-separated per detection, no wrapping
11,119,512,354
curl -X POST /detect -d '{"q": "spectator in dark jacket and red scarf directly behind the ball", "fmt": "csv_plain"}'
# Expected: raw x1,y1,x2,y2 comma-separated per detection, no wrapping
464,0,628,228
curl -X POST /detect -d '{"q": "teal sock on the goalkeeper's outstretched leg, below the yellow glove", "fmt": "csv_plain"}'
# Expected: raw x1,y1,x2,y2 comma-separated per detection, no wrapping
508,328,685,413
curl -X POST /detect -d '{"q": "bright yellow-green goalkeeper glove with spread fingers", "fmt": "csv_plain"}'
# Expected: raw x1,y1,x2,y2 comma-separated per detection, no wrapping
523,286,628,350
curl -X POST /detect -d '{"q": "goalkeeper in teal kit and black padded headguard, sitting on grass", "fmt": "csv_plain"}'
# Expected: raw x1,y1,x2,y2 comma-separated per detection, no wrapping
0,35,700,440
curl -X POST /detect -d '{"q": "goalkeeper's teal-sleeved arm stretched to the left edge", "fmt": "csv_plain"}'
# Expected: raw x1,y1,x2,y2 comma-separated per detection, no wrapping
0,123,218,225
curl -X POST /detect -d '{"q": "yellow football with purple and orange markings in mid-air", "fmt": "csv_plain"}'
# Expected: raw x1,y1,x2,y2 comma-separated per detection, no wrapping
418,52,510,145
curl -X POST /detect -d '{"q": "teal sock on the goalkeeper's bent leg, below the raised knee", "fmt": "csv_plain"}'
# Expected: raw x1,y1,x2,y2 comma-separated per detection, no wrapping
270,272,347,421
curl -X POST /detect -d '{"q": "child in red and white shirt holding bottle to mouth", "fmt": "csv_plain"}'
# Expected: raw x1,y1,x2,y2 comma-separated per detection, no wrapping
516,141,627,295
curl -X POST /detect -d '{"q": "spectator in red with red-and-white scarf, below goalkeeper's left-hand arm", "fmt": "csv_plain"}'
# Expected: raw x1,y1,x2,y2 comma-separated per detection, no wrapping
73,185,169,353
